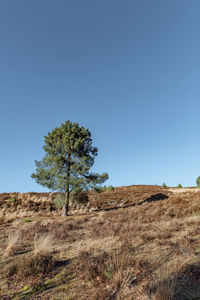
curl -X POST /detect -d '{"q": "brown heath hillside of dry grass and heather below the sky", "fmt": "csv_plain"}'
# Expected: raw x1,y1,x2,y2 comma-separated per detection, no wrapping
0,186,200,300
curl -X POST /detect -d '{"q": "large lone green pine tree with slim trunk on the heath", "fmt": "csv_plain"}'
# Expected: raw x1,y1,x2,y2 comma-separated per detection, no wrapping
31,121,108,216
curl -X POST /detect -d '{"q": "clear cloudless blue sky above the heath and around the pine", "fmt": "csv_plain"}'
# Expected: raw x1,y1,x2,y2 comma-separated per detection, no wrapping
0,0,200,192
